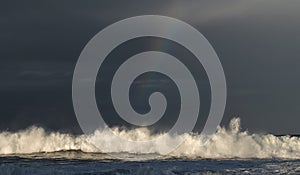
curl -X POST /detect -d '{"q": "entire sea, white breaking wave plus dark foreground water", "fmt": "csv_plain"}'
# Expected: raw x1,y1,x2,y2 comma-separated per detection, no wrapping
0,118,300,175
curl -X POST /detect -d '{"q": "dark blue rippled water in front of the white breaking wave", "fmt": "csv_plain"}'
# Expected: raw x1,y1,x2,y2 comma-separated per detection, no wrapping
0,151,300,175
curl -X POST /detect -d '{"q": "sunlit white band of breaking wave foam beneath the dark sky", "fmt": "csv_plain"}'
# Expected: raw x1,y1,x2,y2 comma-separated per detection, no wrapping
0,118,300,159
